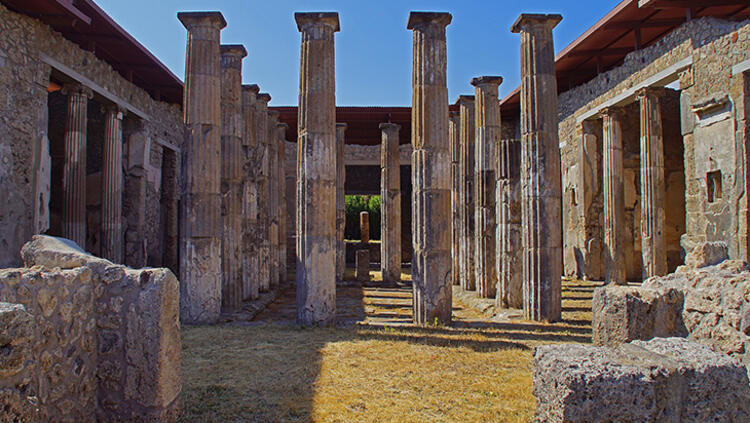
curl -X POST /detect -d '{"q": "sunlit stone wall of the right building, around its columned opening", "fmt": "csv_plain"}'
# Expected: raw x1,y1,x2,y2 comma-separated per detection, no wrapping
559,18,750,280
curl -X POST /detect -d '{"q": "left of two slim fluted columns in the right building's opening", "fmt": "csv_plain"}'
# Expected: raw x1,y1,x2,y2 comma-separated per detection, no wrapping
602,109,627,284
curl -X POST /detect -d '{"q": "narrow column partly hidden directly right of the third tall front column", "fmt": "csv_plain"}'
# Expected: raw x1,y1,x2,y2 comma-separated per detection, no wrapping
448,112,461,285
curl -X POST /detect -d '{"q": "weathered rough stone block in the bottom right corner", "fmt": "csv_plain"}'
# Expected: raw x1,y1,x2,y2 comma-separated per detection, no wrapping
534,338,750,422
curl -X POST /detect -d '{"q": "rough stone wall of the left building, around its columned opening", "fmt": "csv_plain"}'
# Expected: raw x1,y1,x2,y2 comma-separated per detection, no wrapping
0,5,184,268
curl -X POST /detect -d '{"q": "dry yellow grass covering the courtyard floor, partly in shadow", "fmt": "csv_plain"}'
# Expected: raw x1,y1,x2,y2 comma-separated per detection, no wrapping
182,281,592,422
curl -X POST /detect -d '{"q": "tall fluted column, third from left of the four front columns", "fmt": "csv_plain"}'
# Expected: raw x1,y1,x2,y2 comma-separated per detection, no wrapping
407,12,452,325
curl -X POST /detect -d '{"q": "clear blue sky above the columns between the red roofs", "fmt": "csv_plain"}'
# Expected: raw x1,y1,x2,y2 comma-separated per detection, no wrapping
95,0,620,106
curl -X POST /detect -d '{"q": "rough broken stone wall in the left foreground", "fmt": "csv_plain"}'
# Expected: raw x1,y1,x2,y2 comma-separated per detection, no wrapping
0,236,182,421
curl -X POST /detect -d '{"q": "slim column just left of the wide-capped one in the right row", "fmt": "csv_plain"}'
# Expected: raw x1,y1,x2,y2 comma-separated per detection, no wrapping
456,95,476,291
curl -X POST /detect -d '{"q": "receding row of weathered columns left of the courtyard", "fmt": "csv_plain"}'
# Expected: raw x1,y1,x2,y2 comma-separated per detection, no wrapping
178,12,287,323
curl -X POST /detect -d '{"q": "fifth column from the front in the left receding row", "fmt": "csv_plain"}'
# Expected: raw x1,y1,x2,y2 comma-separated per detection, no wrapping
267,110,281,286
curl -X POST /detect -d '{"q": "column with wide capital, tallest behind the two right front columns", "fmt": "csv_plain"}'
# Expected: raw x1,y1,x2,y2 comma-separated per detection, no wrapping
471,76,503,298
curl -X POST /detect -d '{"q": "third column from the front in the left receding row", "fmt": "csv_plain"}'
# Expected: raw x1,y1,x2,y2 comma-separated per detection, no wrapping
242,84,263,300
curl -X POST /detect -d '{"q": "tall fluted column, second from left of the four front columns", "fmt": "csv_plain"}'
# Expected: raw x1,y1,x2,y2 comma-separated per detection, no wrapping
294,13,340,325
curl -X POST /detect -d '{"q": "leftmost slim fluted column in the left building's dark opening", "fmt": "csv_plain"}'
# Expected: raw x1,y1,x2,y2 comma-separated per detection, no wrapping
62,84,93,249
